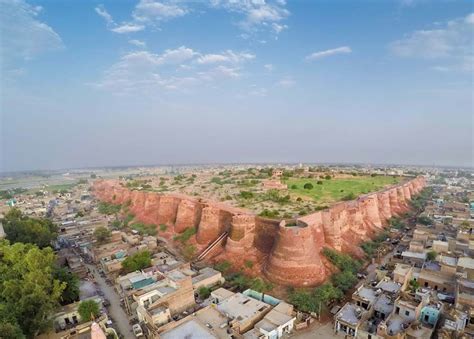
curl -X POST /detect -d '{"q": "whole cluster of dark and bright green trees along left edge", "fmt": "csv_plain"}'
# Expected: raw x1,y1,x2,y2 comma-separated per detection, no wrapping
0,209,79,339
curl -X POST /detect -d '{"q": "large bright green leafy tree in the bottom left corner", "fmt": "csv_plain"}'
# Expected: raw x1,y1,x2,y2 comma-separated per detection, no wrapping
0,241,66,337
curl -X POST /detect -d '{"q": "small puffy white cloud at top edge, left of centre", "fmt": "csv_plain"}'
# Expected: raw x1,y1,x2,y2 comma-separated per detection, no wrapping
133,0,188,22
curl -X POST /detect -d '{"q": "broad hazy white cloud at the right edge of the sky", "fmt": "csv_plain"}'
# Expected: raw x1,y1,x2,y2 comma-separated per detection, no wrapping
389,13,474,71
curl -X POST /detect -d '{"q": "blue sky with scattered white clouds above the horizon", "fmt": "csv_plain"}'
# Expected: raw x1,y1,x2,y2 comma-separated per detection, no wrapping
0,0,474,171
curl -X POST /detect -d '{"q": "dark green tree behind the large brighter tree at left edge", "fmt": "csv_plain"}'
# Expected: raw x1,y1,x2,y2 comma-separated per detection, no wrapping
3,208,58,248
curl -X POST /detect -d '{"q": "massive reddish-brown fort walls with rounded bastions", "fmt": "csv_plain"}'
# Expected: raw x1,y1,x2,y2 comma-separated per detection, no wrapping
93,177,425,287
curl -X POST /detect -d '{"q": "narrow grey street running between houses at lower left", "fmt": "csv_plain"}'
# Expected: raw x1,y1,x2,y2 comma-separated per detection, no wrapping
87,265,135,338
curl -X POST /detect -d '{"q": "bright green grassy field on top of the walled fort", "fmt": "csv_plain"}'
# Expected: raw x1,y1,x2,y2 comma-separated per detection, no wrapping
285,176,400,203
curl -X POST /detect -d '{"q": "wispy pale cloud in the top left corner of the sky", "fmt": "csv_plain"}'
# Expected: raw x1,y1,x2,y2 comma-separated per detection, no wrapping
0,0,64,65
